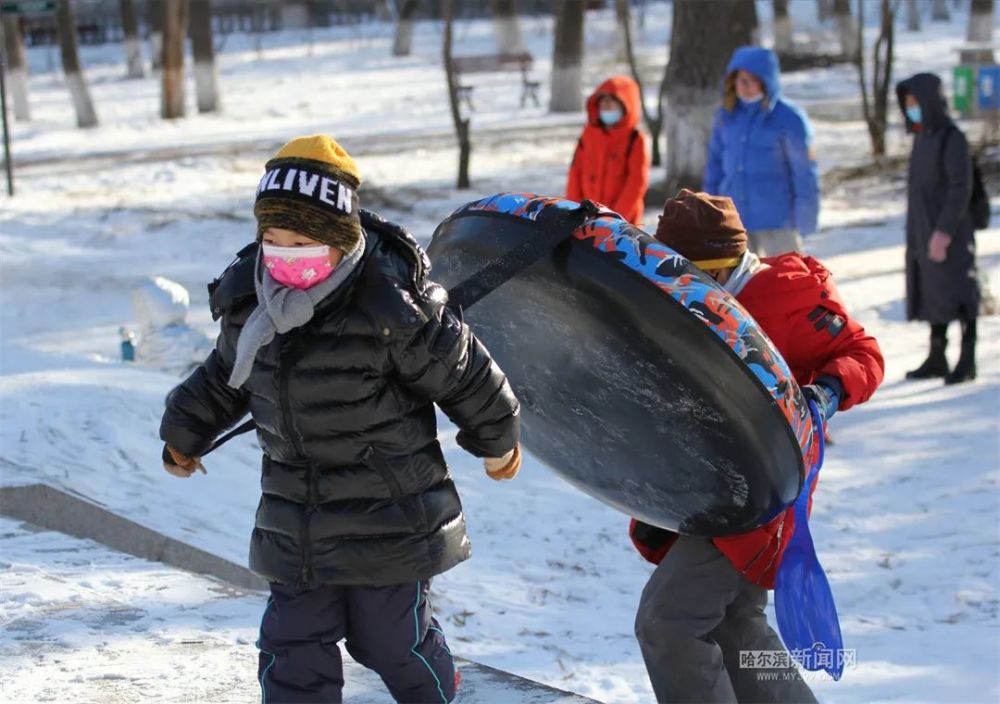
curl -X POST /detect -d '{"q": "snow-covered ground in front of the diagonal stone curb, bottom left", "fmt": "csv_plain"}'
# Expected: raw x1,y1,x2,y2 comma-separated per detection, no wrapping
0,518,589,704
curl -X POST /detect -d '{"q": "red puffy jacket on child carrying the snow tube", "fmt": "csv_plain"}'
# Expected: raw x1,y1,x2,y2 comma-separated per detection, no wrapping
629,252,885,589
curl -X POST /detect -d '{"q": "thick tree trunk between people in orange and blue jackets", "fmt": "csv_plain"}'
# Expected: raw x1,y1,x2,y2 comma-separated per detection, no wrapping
666,0,753,193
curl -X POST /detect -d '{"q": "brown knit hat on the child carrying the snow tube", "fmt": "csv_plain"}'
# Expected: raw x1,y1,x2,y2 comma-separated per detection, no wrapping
656,188,747,269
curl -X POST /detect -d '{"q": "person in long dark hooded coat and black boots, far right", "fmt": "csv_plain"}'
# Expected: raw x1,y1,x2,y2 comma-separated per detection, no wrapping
896,73,979,384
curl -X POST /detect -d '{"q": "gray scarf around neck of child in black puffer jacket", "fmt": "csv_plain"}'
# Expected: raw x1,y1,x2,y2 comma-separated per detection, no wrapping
228,235,365,389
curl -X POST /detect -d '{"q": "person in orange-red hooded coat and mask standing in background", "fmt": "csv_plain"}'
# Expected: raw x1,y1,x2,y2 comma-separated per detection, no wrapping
566,76,649,225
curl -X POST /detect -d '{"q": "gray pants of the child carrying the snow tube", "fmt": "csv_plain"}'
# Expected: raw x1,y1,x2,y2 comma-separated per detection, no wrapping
635,535,816,704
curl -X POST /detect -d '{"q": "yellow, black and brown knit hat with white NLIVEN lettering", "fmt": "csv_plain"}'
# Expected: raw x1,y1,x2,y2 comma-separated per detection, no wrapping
253,134,361,254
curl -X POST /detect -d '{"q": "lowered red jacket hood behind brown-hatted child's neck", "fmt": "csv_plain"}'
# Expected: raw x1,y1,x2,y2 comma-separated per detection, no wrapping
737,252,830,314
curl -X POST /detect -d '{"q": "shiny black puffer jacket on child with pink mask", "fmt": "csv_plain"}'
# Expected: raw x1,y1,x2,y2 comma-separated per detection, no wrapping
160,212,519,588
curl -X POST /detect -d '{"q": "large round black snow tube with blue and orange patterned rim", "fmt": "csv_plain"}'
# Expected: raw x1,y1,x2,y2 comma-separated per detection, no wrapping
428,193,813,537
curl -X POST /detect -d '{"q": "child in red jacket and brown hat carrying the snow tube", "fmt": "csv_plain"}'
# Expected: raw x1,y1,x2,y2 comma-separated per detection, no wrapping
630,190,884,702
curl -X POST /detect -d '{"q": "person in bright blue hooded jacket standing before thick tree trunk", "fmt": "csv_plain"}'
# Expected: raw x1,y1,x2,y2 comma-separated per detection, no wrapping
703,46,819,256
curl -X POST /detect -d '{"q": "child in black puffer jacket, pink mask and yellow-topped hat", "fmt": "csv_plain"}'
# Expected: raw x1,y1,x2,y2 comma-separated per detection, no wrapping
160,136,521,704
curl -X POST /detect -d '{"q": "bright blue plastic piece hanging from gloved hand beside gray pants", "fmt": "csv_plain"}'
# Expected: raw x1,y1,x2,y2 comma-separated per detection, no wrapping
774,401,844,680
